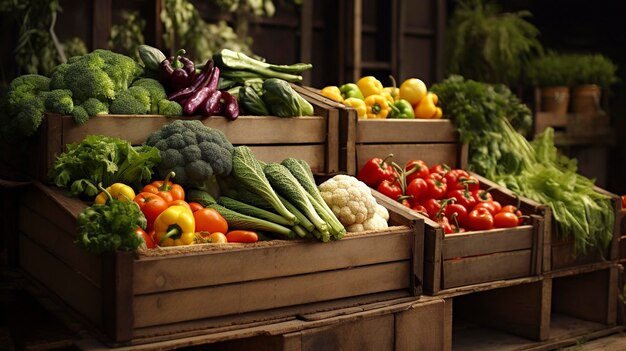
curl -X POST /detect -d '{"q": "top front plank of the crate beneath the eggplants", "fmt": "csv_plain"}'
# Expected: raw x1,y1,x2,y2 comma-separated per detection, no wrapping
62,115,326,145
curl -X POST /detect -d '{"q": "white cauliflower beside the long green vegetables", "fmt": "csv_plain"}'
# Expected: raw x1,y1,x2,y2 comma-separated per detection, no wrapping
319,174,389,232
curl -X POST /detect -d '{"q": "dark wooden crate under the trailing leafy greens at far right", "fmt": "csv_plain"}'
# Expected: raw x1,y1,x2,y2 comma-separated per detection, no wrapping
543,187,621,272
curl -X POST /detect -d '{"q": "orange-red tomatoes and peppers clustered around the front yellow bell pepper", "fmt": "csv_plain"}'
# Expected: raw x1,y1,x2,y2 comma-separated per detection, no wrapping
133,177,259,249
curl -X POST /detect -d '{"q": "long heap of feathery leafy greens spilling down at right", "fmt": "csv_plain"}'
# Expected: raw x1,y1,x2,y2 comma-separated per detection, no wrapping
431,76,615,252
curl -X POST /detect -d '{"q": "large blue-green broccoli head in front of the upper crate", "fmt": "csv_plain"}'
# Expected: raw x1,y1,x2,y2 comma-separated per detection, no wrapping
146,120,234,196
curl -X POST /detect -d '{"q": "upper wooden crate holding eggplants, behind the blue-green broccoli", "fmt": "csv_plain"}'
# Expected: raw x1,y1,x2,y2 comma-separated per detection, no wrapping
23,88,339,182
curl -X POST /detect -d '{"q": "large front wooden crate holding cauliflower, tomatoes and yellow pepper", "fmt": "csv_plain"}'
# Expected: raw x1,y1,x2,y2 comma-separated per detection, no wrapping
15,183,423,344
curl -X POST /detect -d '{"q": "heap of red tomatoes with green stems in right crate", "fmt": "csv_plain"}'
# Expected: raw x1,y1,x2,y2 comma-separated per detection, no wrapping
357,158,523,234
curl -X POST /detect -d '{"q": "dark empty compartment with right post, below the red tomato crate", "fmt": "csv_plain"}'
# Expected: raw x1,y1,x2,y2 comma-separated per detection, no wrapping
454,280,551,340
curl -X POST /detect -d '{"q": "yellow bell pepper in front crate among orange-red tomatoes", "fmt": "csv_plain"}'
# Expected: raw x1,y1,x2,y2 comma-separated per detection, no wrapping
153,205,196,246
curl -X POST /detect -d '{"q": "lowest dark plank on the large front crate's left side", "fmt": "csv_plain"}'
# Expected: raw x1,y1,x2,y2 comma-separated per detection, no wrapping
19,235,103,326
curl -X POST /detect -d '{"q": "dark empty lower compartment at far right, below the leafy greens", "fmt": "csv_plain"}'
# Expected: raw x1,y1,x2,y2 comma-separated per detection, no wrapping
552,266,617,324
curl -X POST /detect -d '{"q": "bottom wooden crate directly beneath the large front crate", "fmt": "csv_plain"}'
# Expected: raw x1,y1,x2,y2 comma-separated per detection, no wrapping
197,298,452,351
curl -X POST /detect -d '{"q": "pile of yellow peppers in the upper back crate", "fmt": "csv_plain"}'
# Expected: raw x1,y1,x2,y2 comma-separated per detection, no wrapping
320,76,443,119
